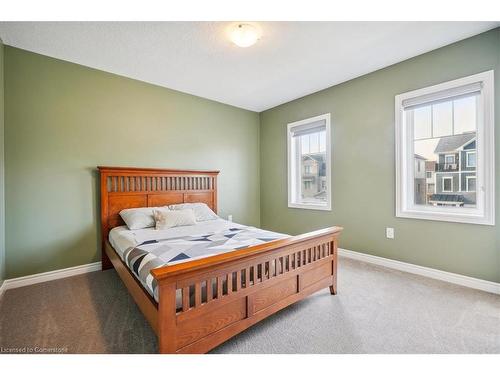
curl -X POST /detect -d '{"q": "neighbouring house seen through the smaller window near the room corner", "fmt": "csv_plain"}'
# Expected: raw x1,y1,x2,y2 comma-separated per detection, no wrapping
302,153,326,200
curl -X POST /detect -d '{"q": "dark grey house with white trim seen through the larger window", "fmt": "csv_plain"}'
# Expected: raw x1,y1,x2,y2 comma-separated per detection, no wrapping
429,132,476,207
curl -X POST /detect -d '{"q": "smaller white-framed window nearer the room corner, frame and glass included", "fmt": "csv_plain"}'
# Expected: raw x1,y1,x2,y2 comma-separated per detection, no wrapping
287,113,331,210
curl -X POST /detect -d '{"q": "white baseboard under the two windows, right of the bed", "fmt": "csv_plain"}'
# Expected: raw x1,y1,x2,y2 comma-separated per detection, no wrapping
339,249,500,294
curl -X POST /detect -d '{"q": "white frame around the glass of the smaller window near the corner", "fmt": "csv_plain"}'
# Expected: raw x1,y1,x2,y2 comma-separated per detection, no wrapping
287,113,332,211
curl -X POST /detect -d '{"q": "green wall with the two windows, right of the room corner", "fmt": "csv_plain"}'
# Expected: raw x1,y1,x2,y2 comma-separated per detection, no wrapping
260,29,500,282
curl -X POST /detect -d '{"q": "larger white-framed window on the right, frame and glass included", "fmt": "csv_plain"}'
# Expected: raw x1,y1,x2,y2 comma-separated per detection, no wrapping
395,71,495,225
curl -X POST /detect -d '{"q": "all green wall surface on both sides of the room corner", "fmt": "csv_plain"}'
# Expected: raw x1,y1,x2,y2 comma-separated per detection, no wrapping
0,29,500,282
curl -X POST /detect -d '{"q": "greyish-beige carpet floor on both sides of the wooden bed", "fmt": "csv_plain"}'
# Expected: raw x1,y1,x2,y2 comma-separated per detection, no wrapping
0,258,500,353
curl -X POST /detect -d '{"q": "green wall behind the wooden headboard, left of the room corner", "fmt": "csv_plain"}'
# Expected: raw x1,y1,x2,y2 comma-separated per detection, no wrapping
5,46,260,278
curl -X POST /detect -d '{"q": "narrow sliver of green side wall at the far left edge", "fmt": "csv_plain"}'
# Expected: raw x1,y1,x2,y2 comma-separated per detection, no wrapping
0,39,5,286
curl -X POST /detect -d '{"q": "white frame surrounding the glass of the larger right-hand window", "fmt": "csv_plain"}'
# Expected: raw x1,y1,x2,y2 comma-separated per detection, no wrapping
395,70,495,225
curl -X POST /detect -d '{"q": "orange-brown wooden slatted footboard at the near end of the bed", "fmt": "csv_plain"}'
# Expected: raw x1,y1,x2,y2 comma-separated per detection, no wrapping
151,227,342,353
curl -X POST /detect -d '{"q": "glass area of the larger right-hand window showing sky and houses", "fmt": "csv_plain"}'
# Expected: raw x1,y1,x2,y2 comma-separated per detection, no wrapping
409,97,476,207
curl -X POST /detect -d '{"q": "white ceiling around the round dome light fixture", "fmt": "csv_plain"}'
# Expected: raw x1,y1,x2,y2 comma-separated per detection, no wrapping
0,22,500,112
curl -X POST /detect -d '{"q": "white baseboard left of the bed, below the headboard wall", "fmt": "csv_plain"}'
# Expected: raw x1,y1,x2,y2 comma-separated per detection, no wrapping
0,262,101,297
